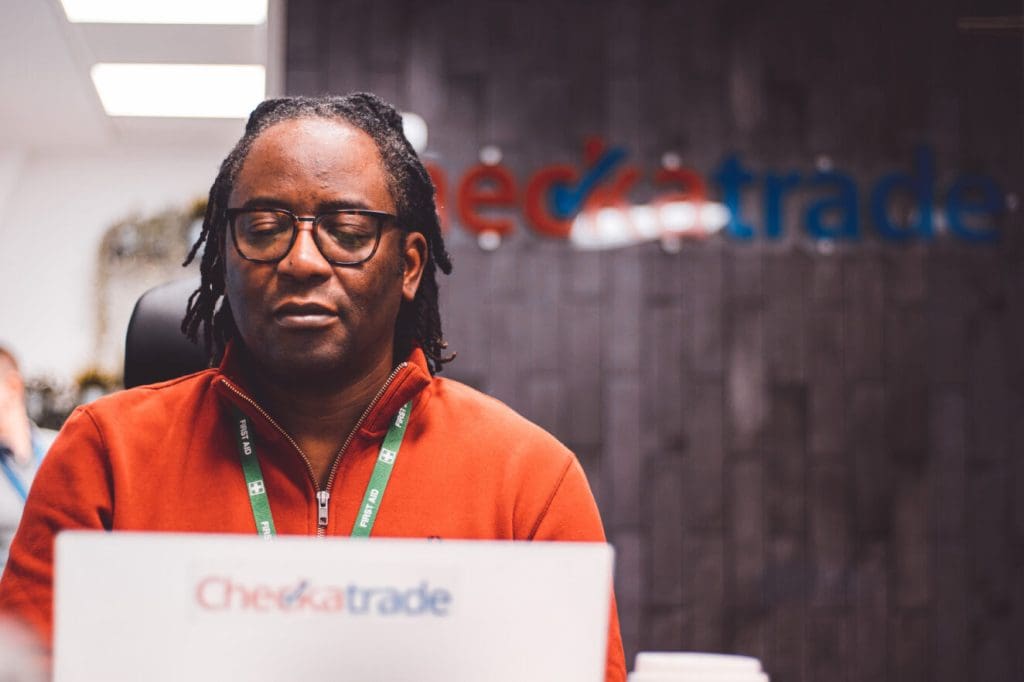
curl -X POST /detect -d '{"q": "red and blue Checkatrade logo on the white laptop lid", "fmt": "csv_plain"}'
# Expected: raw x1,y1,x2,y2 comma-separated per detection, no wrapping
195,574,452,617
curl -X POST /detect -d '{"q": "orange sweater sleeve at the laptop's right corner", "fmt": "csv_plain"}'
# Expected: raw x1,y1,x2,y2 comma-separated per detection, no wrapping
529,456,626,682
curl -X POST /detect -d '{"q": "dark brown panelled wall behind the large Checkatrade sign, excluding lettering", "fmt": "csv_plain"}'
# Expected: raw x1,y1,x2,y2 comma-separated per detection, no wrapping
287,0,1024,682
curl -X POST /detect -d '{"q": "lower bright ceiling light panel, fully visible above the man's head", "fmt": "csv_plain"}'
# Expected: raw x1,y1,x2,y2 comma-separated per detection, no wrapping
92,63,266,119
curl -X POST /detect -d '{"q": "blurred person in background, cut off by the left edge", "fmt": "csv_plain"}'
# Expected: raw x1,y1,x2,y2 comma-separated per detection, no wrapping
0,346,56,570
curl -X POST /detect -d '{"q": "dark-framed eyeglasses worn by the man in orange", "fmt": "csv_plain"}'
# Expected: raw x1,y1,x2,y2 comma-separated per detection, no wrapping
227,209,396,265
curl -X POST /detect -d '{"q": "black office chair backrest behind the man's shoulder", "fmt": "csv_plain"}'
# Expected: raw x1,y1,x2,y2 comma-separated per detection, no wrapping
125,276,207,388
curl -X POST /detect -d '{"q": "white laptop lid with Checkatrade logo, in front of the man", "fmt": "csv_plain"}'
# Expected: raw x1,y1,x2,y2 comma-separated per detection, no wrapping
54,531,612,682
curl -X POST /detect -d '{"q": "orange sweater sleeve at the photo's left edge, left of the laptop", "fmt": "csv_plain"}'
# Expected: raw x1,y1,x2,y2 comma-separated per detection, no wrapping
0,408,113,647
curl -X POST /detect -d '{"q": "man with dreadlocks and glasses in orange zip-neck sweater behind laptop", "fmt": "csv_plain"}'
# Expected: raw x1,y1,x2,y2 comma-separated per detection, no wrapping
0,94,625,680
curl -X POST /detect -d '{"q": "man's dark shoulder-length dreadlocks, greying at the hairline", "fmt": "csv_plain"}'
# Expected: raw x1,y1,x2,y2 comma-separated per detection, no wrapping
181,92,455,373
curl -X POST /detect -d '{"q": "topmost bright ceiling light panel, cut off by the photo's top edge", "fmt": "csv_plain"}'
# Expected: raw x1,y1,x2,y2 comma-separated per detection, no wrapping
60,0,267,25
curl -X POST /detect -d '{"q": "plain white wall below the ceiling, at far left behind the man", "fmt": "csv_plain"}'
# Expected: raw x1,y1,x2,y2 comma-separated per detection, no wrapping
0,144,230,382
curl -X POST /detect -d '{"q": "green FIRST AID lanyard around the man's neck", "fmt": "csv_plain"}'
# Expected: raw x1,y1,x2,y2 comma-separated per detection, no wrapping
234,401,413,540
